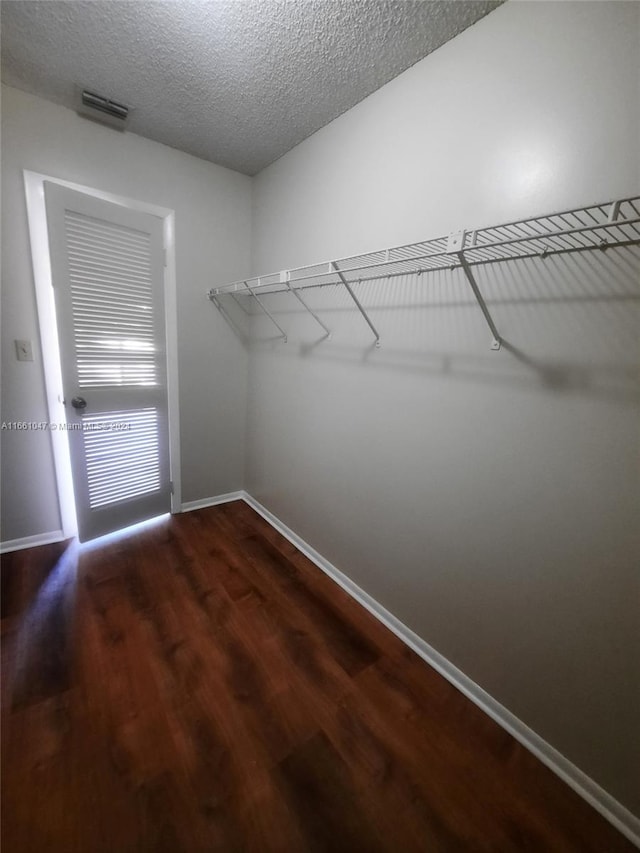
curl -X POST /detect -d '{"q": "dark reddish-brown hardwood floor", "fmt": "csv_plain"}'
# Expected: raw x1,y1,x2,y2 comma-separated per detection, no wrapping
2,502,635,853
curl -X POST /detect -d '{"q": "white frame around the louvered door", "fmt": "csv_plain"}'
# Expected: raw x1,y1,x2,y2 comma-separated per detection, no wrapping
23,169,182,538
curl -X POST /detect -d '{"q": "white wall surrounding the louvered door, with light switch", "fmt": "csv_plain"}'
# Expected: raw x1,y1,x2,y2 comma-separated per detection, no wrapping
2,86,251,541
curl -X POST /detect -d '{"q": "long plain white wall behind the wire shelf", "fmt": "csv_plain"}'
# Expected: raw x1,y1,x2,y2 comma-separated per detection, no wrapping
247,2,640,813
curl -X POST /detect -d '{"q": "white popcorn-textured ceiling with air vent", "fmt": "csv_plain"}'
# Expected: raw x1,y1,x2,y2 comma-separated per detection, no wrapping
0,0,502,175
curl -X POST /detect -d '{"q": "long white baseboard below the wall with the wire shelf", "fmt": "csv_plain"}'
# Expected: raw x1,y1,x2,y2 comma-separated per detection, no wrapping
241,492,640,848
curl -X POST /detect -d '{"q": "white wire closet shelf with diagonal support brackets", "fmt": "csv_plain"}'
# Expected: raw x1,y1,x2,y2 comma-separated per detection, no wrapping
208,196,640,349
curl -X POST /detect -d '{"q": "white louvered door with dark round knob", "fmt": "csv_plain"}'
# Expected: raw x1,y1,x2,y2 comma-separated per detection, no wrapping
45,182,171,542
